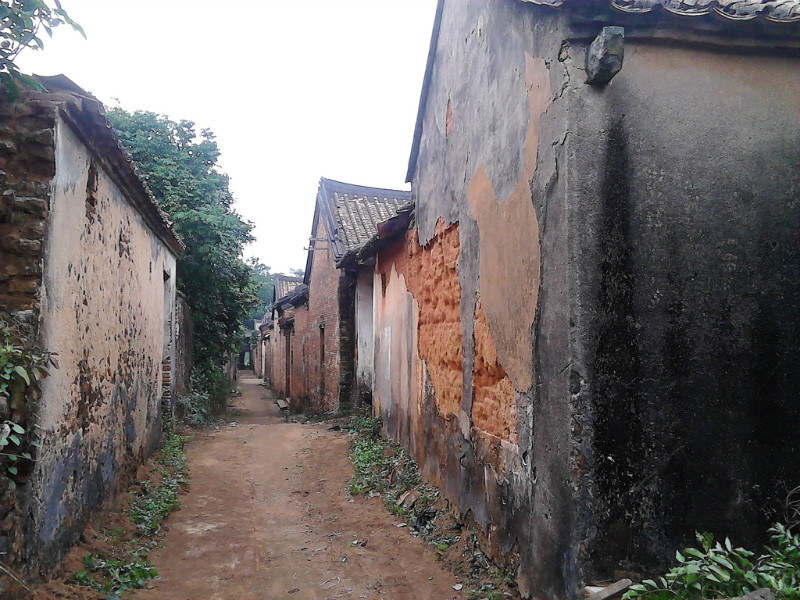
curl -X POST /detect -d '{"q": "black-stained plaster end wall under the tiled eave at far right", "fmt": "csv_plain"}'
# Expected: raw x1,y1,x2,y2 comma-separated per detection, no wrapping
566,39,800,576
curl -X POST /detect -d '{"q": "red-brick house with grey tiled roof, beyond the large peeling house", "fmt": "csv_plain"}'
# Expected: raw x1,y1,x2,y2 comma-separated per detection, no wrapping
292,178,411,412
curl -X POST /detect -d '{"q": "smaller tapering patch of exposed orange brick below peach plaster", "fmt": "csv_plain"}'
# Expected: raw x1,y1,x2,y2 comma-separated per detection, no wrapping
472,300,517,444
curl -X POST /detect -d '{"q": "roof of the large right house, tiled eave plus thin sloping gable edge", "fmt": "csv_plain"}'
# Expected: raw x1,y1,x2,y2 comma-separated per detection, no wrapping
406,0,800,182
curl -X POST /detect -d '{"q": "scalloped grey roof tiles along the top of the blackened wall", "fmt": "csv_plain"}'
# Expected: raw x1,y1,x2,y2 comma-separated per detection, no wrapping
523,0,800,23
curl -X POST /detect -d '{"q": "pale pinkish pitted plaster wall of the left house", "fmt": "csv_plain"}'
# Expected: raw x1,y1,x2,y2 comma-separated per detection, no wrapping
23,119,176,570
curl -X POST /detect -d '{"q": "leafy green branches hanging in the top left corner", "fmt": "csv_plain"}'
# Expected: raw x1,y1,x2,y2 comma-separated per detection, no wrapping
0,0,86,92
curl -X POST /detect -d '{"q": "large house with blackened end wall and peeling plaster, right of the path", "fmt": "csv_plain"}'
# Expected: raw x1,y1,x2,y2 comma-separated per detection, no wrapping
372,0,800,599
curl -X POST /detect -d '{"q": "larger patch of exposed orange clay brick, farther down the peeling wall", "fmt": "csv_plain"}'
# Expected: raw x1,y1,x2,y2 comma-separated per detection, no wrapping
376,220,462,415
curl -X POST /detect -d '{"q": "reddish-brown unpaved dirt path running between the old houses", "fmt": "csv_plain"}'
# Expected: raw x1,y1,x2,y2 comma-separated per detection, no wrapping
131,372,465,600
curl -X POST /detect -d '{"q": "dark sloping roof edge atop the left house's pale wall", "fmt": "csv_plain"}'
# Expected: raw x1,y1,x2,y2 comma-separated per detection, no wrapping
34,75,185,255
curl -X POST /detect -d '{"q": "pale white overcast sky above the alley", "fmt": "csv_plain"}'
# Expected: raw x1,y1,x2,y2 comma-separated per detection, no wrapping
18,0,436,273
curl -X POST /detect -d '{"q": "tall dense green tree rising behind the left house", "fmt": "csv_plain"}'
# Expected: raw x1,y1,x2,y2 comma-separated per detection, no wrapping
108,108,257,408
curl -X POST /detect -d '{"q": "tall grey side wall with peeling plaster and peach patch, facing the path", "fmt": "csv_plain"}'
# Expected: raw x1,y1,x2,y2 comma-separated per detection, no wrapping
412,0,582,598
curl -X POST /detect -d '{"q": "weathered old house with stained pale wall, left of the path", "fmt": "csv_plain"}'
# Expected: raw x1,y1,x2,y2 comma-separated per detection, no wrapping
0,76,182,595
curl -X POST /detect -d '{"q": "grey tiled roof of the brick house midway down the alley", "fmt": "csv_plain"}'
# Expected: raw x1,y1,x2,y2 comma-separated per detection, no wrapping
312,177,411,265
